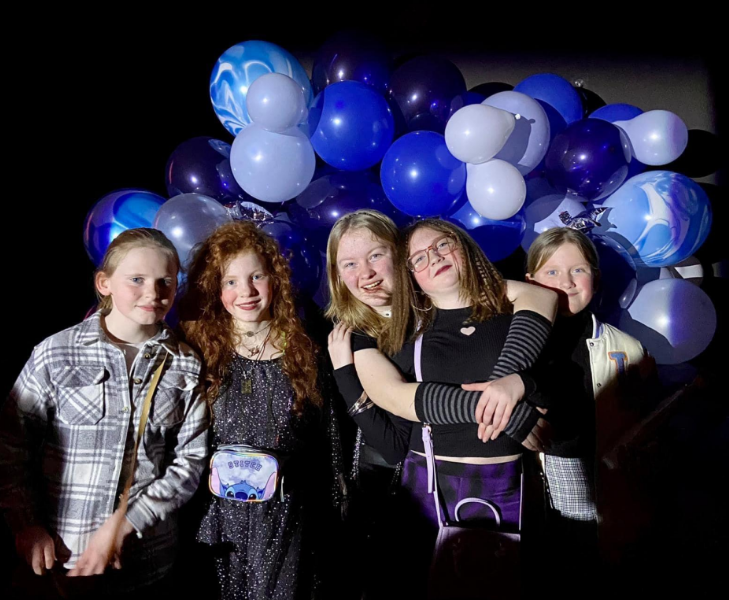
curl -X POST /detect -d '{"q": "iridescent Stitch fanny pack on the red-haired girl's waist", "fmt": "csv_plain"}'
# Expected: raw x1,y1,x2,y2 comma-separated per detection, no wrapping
208,444,283,502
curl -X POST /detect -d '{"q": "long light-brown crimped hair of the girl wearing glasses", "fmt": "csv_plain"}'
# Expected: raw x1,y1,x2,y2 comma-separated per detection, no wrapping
381,219,513,356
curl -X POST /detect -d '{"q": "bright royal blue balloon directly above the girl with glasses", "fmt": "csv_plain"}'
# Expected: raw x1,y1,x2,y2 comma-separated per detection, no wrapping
380,131,466,217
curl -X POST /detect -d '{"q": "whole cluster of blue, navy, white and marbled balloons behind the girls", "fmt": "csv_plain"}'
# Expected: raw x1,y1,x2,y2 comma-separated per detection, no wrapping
84,32,715,362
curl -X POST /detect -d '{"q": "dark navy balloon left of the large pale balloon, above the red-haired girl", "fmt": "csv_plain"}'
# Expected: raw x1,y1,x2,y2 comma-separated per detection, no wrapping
165,137,245,204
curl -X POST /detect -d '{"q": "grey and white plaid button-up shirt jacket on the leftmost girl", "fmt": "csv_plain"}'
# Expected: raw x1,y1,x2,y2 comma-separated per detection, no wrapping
0,313,209,583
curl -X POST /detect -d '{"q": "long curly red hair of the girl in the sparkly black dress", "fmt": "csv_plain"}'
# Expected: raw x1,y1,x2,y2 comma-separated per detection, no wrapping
179,221,322,415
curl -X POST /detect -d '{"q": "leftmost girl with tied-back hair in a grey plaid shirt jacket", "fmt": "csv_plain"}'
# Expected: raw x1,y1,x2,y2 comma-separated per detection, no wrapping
0,229,208,599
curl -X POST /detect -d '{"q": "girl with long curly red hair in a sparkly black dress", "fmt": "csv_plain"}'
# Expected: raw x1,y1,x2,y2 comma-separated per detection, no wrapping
180,222,341,599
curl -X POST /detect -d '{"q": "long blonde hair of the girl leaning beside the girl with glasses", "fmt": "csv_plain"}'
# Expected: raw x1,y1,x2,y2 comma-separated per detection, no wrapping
326,209,400,339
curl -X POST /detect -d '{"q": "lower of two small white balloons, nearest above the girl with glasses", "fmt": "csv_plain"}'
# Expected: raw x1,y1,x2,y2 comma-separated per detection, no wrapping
466,159,526,221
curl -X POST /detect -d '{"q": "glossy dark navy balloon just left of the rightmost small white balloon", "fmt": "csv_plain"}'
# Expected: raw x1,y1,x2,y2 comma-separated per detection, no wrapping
544,119,631,200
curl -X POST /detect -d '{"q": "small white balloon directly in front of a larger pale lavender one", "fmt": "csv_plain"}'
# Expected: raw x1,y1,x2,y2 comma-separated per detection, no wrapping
445,104,516,164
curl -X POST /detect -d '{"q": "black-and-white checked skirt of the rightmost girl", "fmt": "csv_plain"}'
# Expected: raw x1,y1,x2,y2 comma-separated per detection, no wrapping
544,455,597,521
